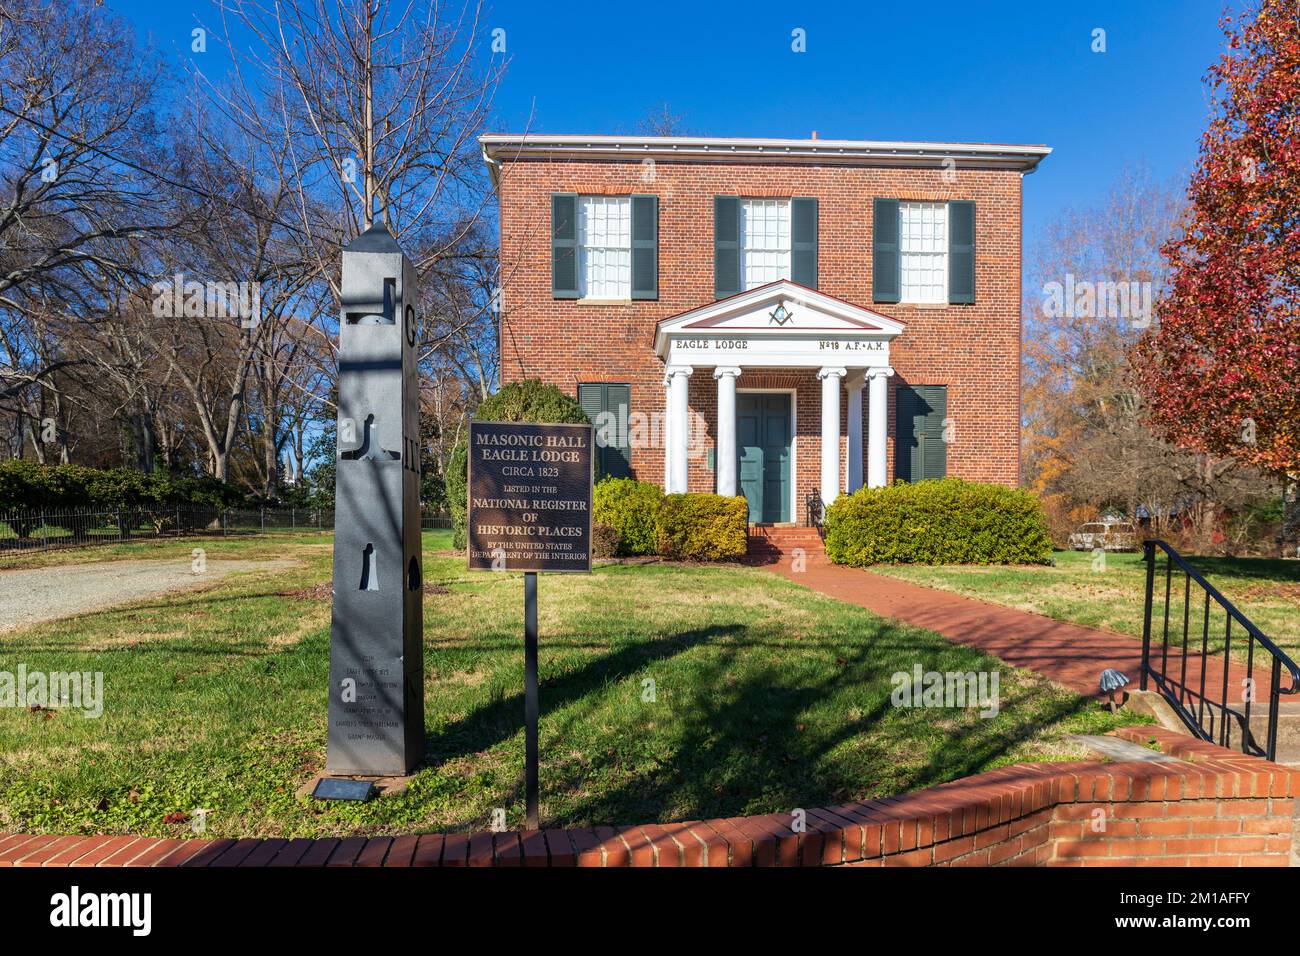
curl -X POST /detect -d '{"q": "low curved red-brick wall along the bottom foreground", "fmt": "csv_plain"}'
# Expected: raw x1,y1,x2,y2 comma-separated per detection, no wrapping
0,727,1300,868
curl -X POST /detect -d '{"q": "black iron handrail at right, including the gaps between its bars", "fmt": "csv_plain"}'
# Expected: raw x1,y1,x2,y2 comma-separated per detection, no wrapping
1140,540,1300,760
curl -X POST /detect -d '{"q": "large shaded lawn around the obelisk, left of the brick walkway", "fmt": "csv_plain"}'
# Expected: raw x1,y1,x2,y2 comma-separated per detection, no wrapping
0,532,1138,836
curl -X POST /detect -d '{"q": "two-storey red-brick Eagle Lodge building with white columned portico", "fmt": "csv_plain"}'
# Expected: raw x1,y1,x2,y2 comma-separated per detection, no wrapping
481,134,1050,524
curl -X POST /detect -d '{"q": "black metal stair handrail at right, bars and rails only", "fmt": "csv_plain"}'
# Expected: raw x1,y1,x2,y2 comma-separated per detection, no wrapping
1140,540,1300,760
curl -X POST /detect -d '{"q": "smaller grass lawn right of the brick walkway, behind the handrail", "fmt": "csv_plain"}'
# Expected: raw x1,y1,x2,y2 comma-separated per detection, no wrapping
871,551,1300,661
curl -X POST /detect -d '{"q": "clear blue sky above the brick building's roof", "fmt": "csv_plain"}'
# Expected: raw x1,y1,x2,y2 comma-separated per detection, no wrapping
107,0,1242,251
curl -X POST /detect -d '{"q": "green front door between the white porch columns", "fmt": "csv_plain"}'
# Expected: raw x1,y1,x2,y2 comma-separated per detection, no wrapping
736,392,790,524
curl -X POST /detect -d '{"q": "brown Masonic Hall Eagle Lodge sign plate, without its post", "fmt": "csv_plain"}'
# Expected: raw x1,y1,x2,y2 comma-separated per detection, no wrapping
467,421,592,571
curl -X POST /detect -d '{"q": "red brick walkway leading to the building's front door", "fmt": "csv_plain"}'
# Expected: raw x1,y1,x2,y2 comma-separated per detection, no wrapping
757,548,1269,701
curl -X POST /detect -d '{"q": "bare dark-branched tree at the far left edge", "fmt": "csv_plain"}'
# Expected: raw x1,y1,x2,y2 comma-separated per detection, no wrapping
0,0,165,460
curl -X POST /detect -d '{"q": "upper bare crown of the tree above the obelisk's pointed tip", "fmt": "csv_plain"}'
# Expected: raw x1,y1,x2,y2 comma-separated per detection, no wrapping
198,0,503,300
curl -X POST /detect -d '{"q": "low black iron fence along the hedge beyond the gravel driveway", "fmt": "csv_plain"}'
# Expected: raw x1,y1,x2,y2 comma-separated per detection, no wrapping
0,505,451,553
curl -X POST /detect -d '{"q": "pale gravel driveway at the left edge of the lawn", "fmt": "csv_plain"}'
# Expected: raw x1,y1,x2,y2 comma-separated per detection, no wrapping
0,558,298,632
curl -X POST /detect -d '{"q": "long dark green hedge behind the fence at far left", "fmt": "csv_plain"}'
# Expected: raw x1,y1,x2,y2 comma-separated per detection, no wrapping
0,459,247,511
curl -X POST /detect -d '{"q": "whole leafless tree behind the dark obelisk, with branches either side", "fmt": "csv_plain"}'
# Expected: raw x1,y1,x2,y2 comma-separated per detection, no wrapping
188,0,504,489
